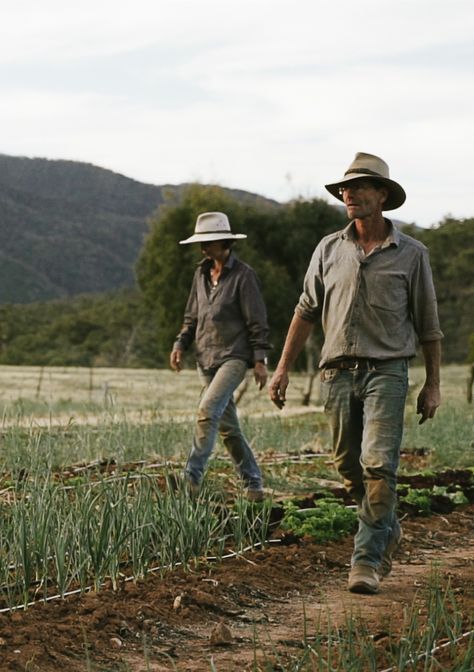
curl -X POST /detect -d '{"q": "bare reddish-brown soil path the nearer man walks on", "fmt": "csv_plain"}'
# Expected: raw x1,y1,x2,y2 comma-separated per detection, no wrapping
0,488,474,672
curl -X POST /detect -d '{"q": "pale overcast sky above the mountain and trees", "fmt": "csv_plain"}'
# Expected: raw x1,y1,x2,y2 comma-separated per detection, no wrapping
0,0,474,226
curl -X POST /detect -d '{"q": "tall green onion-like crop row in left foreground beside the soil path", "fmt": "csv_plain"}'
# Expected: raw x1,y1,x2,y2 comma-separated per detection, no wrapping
0,474,269,607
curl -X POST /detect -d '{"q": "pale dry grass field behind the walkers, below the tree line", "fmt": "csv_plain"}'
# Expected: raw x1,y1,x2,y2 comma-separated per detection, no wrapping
0,366,468,466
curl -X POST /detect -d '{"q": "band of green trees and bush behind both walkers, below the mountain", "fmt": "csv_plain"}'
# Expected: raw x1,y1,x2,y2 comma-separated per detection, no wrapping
0,185,474,367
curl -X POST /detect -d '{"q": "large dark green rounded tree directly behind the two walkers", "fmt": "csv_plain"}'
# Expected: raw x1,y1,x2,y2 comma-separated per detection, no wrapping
136,185,345,368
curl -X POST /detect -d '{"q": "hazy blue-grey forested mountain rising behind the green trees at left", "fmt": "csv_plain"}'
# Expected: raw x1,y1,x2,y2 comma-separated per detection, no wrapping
0,155,274,304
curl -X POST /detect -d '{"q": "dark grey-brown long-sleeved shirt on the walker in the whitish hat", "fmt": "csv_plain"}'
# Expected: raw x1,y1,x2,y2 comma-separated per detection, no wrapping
174,252,270,369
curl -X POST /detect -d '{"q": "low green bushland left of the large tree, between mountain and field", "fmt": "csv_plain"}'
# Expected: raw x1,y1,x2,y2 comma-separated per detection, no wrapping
0,290,154,367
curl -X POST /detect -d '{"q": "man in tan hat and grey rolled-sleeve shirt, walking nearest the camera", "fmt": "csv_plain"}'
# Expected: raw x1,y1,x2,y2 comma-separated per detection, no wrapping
270,153,443,593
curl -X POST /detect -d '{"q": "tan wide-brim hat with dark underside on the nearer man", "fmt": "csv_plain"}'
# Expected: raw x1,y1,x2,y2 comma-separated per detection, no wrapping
325,152,406,210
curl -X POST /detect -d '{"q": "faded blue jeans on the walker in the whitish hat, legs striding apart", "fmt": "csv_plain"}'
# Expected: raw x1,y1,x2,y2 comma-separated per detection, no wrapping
185,359,262,490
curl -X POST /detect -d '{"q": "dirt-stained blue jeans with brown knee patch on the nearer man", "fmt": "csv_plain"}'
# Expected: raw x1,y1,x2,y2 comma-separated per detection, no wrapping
321,359,408,568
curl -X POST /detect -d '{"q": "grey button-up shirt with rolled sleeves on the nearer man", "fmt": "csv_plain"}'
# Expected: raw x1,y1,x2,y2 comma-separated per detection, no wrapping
296,220,443,367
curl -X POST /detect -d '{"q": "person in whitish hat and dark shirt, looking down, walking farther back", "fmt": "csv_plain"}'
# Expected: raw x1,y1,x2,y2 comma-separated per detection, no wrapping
170,212,270,501
